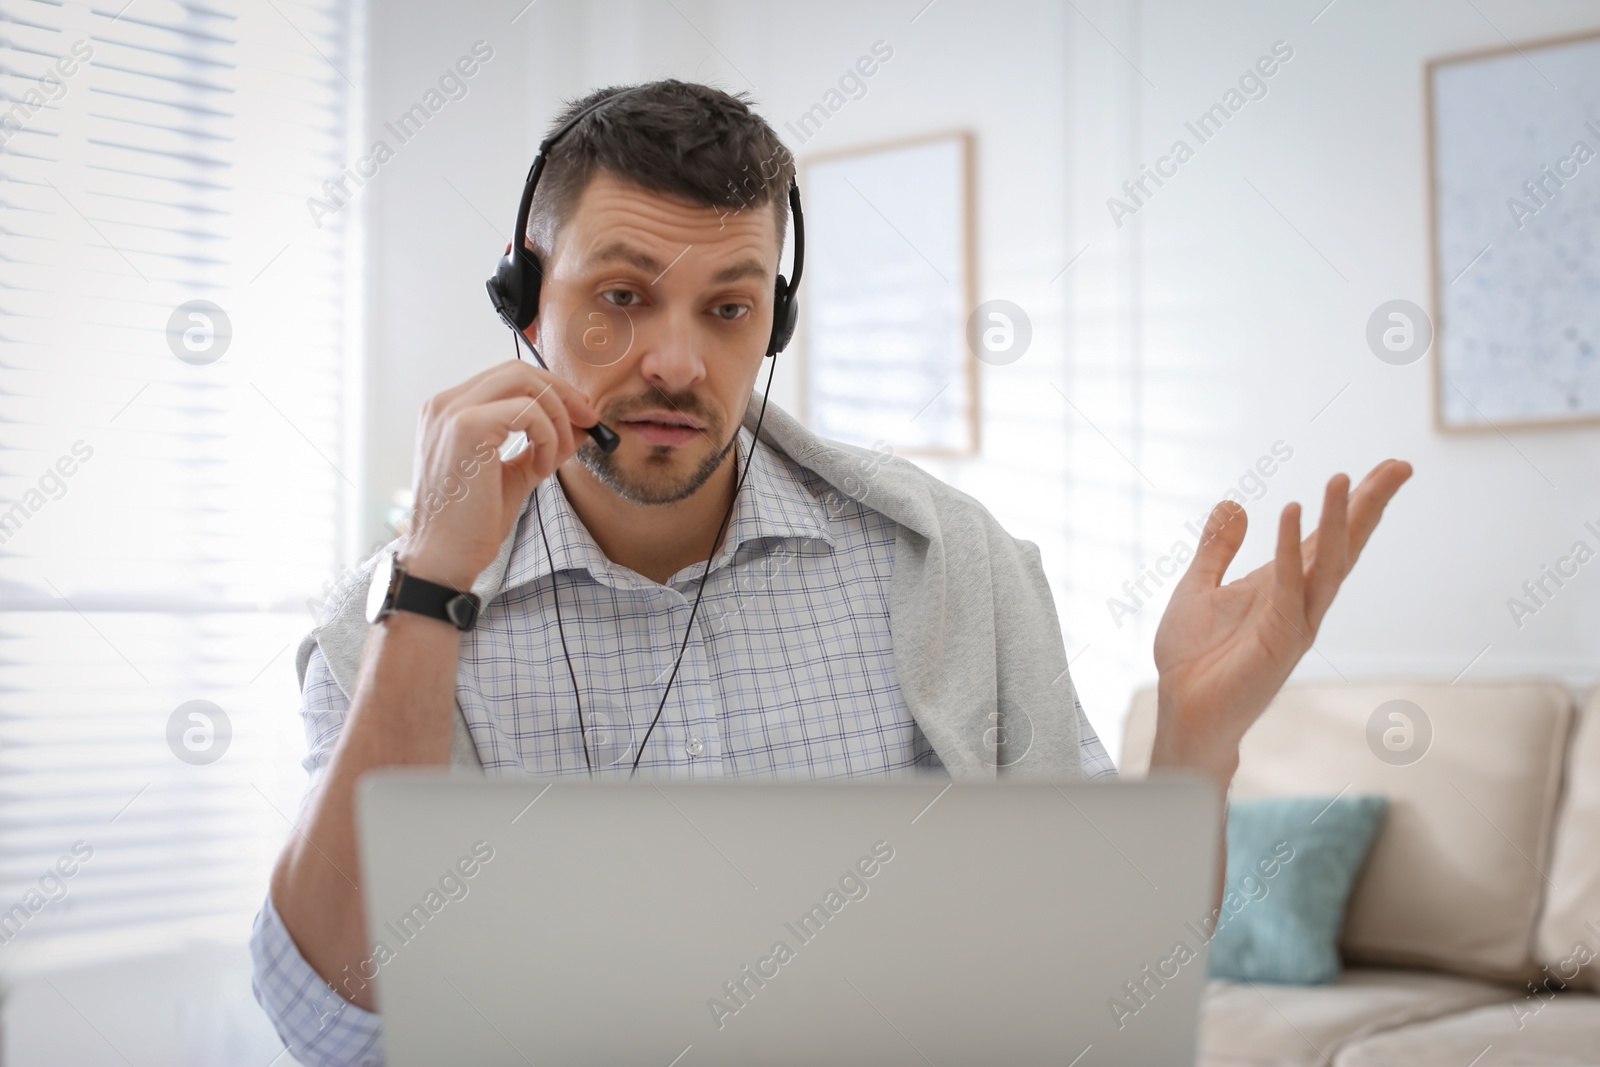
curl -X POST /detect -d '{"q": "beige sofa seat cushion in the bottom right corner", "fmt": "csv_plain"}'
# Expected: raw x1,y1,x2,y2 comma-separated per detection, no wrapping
1333,993,1600,1067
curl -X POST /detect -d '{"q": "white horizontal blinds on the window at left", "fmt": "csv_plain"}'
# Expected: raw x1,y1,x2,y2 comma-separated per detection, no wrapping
0,0,362,966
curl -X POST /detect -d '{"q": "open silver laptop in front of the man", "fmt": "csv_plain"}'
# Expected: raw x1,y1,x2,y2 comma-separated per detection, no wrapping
358,771,1219,1067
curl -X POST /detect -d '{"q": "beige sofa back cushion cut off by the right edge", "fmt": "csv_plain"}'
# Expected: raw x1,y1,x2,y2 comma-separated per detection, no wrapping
1534,686,1600,998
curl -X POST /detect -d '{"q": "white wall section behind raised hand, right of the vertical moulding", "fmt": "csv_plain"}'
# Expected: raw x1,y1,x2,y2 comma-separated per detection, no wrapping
1102,0,1600,716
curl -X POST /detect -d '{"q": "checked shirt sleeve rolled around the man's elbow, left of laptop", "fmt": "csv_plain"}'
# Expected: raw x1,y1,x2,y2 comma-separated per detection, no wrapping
250,896,384,1067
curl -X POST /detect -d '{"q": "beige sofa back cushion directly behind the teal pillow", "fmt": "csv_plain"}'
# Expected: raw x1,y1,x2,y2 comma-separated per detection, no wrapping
1123,681,1573,981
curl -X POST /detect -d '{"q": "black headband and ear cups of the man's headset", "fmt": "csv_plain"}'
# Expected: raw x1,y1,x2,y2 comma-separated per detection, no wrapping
485,88,805,355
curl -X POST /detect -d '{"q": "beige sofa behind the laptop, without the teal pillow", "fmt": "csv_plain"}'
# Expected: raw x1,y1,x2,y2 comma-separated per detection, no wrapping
1122,680,1600,1067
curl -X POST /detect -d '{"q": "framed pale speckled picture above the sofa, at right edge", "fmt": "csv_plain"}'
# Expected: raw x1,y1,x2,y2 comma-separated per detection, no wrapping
1427,32,1600,430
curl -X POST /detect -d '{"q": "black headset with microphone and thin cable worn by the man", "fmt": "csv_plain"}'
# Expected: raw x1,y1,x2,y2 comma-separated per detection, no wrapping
485,86,805,777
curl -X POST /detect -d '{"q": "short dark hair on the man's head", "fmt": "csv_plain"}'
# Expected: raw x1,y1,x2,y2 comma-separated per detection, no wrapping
526,78,795,266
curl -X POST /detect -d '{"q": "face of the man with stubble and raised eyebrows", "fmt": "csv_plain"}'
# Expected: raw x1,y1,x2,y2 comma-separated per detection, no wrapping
528,171,778,504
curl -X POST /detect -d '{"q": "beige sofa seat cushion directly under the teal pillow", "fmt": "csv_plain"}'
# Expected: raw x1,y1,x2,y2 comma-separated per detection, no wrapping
1197,968,1517,1067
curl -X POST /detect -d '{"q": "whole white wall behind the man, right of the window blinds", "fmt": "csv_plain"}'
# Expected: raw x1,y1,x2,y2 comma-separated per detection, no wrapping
363,0,1600,767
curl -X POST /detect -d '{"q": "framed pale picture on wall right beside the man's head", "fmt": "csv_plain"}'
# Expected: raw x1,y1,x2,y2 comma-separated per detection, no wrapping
798,131,978,456
